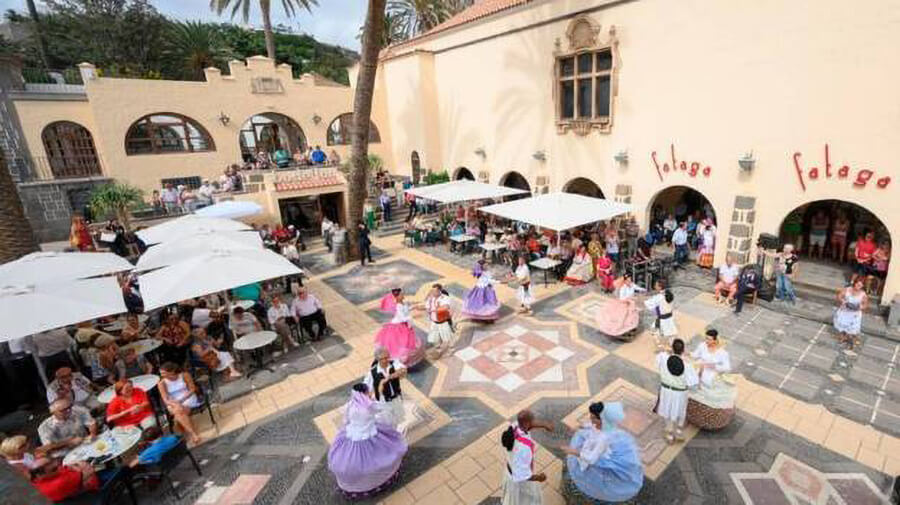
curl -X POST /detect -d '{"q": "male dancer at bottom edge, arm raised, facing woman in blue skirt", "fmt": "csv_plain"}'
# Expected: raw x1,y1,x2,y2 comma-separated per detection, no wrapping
500,410,553,505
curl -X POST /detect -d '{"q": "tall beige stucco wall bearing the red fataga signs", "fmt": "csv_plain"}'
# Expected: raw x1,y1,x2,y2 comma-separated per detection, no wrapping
376,0,900,300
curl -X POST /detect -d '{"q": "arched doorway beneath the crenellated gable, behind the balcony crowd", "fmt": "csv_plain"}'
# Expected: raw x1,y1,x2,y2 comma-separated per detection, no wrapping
240,112,307,161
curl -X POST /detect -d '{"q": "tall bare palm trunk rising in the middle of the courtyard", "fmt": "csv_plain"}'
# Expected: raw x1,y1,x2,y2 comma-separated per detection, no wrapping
347,0,386,257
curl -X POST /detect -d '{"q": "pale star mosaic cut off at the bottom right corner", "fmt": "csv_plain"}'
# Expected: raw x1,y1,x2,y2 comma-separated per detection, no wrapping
731,454,888,505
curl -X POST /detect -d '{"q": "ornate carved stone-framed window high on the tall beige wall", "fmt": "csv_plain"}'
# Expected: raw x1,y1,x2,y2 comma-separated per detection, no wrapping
553,15,619,135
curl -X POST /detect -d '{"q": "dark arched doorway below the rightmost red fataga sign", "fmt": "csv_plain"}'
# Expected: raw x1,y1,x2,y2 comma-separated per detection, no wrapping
778,200,891,294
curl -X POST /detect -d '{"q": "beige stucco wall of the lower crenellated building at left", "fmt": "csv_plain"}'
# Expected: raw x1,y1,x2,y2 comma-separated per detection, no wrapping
15,57,393,194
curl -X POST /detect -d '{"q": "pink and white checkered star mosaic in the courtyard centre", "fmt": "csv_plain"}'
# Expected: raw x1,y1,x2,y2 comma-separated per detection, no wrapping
431,317,607,416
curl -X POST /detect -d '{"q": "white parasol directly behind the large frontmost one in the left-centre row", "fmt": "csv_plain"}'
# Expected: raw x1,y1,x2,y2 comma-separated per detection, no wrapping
135,231,263,271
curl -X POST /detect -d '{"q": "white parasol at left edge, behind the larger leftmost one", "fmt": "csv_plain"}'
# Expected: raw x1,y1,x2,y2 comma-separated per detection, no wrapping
0,252,133,287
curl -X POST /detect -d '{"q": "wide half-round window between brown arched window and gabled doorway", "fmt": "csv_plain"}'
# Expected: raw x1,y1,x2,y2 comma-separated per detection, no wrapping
125,112,216,155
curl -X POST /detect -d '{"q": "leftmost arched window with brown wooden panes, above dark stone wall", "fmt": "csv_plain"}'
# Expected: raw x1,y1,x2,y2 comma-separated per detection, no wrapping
41,121,100,178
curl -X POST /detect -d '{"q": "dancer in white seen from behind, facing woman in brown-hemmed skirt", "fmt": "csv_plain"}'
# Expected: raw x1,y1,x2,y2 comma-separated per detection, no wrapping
656,338,700,444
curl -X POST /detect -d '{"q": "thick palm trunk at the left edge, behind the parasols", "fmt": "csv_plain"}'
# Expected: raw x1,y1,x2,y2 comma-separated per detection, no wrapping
0,155,39,263
